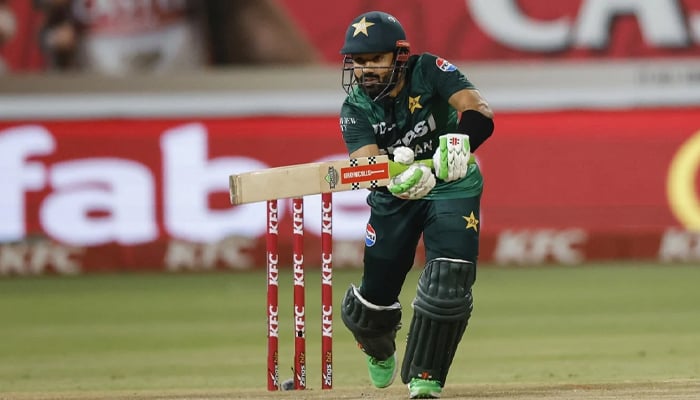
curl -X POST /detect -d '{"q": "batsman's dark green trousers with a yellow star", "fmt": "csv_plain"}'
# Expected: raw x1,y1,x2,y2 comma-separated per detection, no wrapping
360,193,481,306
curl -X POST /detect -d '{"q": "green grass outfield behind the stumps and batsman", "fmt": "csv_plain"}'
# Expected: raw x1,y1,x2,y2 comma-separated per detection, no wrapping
0,264,700,400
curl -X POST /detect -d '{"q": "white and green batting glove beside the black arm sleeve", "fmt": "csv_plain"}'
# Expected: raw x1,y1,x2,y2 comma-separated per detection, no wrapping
433,133,471,182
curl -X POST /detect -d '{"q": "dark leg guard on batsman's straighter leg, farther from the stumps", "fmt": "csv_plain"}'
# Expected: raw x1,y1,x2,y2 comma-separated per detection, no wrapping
401,258,476,386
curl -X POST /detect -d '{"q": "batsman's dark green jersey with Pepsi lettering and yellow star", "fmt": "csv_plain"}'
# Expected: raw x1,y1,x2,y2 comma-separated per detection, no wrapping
340,53,483,199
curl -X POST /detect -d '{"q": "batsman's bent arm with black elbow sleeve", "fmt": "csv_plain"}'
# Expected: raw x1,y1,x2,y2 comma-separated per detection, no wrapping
448,89,494,152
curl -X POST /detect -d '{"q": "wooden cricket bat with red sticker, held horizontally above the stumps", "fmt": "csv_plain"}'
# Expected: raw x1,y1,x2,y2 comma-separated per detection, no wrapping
229,155,433,205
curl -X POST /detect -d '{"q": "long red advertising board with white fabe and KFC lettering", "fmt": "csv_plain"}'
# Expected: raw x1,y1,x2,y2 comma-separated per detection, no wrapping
0,108,700,275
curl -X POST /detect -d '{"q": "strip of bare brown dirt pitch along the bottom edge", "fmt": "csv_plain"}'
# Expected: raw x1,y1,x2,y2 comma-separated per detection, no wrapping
0,380,700,400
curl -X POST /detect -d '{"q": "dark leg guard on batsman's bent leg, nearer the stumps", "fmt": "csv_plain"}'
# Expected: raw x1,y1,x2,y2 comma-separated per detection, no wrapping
340,285,401,360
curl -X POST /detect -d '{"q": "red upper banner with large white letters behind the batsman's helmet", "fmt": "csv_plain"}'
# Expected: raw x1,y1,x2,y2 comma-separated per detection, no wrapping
280,0,700,62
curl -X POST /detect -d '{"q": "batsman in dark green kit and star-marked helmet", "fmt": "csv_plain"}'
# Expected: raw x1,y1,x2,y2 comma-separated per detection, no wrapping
340,11,494,399
